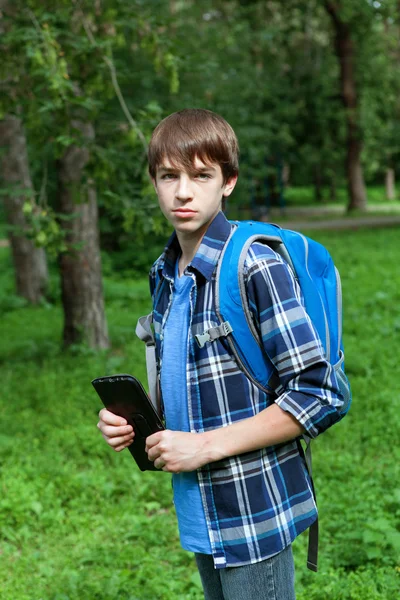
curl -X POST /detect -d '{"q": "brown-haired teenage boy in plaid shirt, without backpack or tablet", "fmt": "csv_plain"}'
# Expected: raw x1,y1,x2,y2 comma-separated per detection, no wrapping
98,109,342,600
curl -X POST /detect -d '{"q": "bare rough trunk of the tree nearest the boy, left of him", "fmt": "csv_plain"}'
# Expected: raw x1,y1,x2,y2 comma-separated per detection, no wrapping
58,120,109,348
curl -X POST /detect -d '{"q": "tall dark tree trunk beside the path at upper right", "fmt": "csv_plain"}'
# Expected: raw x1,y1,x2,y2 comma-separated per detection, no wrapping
325,0,367,211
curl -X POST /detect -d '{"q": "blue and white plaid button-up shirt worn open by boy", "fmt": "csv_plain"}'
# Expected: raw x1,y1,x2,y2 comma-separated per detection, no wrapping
150,213,342,568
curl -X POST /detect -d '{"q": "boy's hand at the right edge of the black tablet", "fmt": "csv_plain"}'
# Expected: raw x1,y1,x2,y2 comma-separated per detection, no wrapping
146,429,210,473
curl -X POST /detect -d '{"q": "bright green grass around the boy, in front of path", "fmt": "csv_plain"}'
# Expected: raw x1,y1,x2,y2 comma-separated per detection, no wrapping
0,228,400,600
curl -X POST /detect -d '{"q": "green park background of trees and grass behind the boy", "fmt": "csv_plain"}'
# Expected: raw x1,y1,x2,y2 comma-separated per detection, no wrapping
0,0,400,600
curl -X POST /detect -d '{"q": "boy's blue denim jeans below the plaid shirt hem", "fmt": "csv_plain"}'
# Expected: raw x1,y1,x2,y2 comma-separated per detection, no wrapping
195,546,296,600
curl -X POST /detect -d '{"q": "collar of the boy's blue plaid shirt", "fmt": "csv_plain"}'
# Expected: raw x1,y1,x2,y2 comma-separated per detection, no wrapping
157,212,232,281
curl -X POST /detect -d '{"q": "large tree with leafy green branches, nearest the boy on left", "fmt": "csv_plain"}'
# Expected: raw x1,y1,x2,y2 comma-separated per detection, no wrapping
1,0,166,348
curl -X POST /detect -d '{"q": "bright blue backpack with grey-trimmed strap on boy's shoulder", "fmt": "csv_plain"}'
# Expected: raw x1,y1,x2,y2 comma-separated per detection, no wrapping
196,221,351,571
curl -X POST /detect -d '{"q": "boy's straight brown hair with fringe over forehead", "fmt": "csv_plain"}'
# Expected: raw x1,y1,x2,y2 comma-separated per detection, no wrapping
148,108,239,183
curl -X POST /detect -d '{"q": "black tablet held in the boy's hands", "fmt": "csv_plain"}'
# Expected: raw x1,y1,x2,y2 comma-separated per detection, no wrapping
92,373,164,471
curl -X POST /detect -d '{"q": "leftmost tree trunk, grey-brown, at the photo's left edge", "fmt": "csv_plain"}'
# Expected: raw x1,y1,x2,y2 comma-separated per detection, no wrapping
0,115,48,303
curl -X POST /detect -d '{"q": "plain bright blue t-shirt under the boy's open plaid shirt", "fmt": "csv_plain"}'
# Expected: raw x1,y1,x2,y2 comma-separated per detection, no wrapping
161,261,211,554
